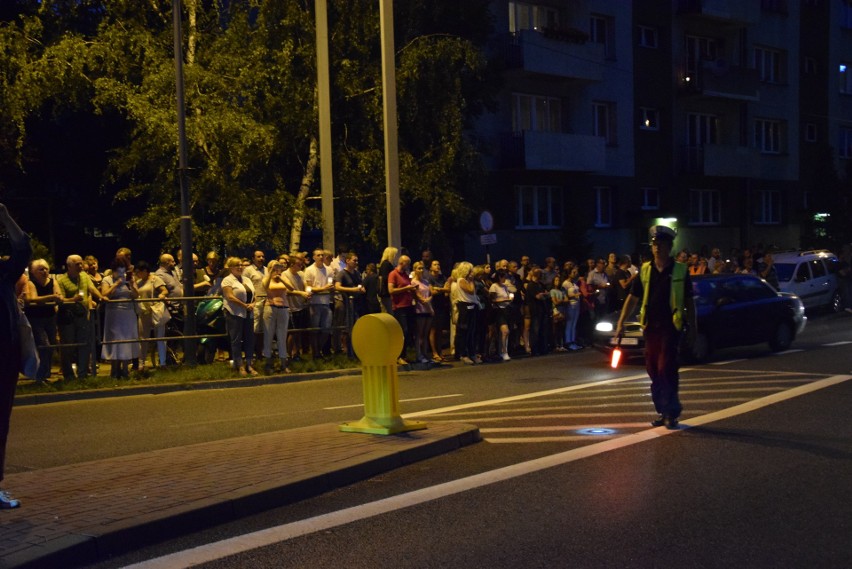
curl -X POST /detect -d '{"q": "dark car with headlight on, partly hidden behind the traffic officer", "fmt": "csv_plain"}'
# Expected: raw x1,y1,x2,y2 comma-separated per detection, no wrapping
594,274,807,361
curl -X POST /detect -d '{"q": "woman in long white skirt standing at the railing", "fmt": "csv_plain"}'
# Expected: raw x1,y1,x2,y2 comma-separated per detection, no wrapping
101,257,139,379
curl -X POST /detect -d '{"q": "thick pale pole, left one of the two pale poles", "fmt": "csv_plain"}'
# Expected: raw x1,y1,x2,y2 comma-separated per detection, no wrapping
315,0,334,251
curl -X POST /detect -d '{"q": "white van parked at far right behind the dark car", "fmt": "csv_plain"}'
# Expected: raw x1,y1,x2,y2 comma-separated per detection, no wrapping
773,249,843,312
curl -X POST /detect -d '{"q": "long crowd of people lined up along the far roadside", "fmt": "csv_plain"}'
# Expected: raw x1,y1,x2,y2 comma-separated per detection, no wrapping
13,240,852,381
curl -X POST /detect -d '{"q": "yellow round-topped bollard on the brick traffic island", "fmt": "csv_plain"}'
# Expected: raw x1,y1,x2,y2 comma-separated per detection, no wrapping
340,314,426,435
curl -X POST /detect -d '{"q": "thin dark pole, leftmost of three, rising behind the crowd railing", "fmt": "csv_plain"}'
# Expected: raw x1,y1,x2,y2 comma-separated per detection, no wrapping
172,0,196,365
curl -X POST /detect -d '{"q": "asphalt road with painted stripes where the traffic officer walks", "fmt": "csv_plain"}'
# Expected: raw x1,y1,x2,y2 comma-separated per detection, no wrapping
9,315,852,568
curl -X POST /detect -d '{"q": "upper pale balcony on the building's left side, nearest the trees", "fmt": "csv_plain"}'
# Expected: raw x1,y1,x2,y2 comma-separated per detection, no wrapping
502,30,604,81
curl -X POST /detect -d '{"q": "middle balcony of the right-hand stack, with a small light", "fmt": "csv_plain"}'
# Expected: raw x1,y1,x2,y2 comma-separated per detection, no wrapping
680,59,760,101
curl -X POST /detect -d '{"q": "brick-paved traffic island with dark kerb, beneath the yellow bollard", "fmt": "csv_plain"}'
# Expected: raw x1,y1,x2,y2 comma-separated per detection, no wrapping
0,423,480,569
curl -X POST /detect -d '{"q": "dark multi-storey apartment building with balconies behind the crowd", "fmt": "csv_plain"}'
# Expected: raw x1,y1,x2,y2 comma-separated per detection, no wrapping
465,0,852,258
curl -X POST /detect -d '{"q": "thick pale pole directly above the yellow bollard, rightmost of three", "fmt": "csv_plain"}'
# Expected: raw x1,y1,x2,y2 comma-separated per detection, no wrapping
379,0,402,247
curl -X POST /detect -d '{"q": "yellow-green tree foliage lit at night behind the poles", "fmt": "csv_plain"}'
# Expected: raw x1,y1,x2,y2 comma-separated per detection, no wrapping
0,0,494,254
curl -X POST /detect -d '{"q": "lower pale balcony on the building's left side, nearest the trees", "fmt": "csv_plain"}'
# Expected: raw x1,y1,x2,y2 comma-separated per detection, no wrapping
501,130,606,172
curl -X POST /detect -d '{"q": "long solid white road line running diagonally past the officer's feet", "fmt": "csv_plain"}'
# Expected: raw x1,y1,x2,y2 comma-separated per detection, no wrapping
129,375,852,569
